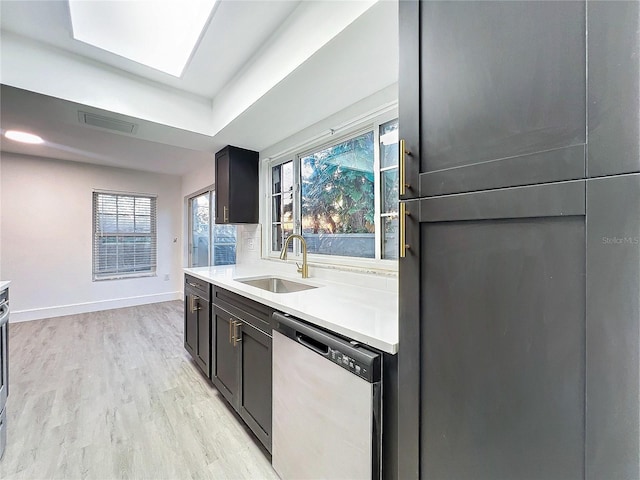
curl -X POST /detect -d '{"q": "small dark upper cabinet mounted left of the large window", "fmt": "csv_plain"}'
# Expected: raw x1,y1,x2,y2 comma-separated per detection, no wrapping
215,145,259,224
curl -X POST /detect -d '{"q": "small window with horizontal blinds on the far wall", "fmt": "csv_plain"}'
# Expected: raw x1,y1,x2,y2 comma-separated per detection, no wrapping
93,192,157,280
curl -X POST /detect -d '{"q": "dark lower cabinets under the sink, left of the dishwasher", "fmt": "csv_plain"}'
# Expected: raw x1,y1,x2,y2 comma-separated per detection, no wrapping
184,275,272,452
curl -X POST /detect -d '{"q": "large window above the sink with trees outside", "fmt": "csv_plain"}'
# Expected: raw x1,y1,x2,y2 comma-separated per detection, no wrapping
270,118,398,263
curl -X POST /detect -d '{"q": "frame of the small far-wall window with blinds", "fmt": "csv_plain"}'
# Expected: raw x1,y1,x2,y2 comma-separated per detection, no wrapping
91,189,158,282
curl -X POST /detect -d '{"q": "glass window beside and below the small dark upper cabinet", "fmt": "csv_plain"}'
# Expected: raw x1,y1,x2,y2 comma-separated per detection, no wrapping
189,190,236,267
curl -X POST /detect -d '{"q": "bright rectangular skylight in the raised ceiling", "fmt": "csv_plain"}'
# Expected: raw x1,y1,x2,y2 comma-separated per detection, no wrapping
69,0,217,77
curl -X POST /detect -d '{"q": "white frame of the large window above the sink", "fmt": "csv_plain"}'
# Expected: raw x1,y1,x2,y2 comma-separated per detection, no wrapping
261,109,398,272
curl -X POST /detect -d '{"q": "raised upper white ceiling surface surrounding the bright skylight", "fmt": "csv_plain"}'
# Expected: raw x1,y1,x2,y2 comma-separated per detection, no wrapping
0,0,300,98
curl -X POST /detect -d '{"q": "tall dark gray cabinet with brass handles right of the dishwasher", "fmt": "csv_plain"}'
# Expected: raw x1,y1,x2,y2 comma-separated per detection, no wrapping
398,0,640,480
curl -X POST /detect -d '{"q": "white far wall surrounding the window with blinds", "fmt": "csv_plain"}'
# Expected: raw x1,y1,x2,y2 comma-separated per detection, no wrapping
0,153,182,321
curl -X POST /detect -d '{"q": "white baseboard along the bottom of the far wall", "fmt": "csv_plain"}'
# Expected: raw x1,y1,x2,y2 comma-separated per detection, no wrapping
9,292,182,323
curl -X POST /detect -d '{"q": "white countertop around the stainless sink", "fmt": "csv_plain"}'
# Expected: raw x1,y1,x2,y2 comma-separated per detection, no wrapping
184,261,398,354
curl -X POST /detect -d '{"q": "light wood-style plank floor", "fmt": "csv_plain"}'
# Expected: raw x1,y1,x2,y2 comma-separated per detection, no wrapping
0,301,278,480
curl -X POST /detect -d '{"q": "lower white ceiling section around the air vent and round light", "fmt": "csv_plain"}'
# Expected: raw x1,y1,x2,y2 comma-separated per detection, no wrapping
0,85,213,175
